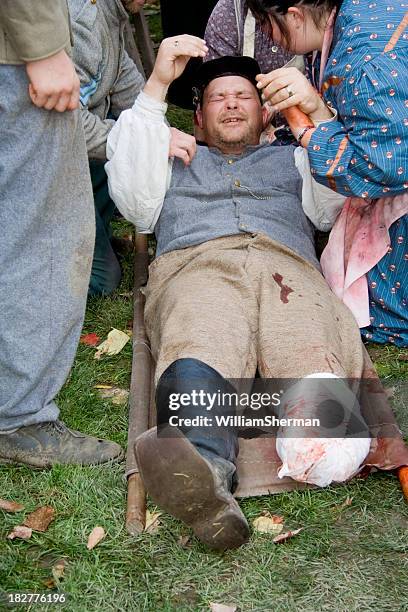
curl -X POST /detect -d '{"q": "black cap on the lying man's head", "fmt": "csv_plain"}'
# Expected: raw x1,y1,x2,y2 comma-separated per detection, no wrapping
193,55,261,105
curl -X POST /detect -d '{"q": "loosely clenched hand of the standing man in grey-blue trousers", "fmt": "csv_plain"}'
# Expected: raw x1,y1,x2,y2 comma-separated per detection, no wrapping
26,50,79,113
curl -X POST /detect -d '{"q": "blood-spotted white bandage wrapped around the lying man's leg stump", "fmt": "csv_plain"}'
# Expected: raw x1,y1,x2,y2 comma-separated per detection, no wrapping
276,373,370,487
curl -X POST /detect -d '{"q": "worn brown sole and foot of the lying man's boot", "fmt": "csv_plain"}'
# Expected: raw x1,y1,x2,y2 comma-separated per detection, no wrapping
135,427,249,550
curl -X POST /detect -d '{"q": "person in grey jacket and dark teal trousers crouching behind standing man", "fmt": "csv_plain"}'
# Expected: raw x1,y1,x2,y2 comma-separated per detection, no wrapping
68,0,144,295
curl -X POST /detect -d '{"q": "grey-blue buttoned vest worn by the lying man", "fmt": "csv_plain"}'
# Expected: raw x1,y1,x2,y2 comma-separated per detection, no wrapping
155,145,319,268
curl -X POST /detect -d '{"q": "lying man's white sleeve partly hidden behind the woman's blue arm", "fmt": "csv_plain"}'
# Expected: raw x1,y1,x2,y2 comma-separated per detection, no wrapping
295,108,346,232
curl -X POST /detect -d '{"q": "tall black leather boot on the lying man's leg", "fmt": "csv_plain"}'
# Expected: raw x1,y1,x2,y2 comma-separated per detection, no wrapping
135,359,249,550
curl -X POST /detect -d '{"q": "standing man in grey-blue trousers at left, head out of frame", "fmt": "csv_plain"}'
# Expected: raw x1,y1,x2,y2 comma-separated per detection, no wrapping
0,0,123,468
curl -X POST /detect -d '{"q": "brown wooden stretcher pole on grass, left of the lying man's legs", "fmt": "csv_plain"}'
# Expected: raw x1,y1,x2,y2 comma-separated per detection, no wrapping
126,234,153,535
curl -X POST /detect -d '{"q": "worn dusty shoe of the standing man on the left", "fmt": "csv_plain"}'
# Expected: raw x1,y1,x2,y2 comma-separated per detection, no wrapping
0,421,124,468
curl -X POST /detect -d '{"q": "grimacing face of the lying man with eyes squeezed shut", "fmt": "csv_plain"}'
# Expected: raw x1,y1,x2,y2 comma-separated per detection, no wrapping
197,76,263,153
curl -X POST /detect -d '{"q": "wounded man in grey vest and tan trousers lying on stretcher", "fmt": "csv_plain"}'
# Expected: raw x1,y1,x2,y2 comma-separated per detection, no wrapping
106,35,386,549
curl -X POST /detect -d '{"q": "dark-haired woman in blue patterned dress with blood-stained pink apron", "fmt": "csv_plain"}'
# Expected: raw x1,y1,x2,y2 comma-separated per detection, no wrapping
248,0,408,346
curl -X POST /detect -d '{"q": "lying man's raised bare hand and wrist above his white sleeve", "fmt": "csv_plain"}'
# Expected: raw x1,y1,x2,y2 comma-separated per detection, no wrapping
144,34,208,102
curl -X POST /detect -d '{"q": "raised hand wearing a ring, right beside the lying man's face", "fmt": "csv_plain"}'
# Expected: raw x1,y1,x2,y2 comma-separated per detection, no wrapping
256,68,332,120
